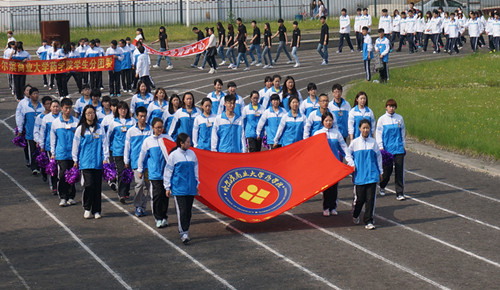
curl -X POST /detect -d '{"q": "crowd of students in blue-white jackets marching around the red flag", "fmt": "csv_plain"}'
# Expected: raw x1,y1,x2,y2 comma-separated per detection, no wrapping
16,75,405,233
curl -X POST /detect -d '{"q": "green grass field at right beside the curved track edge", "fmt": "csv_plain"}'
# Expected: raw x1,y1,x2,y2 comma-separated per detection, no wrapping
347,54,500,161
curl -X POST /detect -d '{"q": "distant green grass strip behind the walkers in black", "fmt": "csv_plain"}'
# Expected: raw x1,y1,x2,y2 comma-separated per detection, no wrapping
0,18,378,49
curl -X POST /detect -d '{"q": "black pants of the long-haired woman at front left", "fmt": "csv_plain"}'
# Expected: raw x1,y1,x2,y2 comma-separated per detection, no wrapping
82,169,102,214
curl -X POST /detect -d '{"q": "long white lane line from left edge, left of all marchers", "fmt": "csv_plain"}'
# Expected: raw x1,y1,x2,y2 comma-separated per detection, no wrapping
0,168,132,290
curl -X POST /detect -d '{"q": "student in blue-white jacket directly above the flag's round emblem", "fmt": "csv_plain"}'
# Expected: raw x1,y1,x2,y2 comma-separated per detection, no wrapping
241,91,264,152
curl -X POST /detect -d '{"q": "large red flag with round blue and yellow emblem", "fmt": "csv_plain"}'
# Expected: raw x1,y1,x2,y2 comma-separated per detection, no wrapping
164,134,353,223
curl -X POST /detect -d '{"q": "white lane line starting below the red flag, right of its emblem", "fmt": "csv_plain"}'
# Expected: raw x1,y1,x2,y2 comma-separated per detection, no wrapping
285,211,449,289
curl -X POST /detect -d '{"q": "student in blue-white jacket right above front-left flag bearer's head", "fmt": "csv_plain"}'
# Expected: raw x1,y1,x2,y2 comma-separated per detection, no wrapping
193,98,216,151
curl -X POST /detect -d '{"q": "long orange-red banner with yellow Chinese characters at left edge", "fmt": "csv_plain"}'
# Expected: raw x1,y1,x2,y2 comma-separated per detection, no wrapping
0,56,115,75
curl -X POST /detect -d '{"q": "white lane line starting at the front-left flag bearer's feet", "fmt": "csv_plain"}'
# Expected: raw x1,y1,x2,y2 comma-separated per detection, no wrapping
193,205,341,289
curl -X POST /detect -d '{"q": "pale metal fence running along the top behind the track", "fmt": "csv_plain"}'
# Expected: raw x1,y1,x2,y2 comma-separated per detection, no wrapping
0,0,500,32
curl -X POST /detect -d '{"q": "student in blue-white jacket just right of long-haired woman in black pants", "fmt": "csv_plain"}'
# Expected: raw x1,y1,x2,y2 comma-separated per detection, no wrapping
108,101,136,204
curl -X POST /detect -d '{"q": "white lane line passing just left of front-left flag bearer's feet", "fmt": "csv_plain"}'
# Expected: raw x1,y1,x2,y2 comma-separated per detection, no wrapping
102,193,236,289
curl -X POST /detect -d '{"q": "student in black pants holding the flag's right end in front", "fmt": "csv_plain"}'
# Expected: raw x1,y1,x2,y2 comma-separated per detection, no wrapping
348,120,383,230
